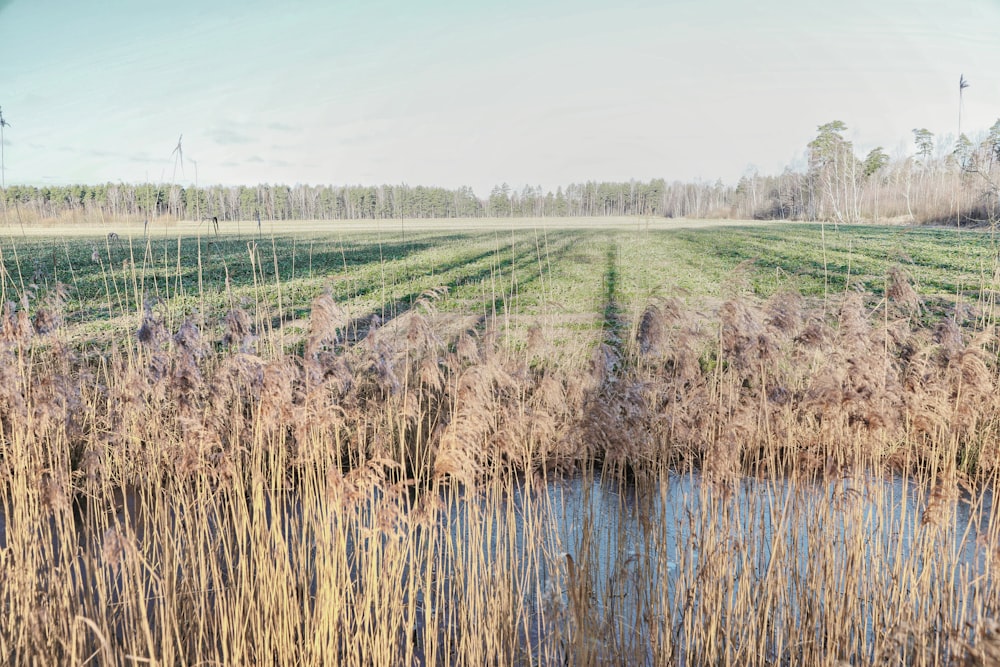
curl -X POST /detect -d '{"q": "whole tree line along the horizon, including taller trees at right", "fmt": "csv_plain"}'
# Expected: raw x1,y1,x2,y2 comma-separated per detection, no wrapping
0,120,1000,224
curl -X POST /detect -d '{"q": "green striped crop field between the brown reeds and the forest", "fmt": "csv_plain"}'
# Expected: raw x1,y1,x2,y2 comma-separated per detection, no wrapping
7,219,997,352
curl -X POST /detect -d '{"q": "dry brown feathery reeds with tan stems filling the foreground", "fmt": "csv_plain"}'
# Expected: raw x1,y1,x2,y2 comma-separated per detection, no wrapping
0,269,1000,664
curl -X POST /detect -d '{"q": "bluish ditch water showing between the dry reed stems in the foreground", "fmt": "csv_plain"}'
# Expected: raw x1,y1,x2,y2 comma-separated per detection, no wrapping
0,473,998,664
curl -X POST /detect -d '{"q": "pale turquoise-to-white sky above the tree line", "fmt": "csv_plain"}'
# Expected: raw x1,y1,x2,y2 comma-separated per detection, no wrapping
0,0,1000,196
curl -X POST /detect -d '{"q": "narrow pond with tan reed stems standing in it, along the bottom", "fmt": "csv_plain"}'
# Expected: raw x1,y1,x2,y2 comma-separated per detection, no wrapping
0,472,1000,664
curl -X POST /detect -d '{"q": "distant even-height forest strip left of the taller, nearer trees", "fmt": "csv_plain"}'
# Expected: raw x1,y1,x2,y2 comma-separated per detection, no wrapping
3,179,733,220
